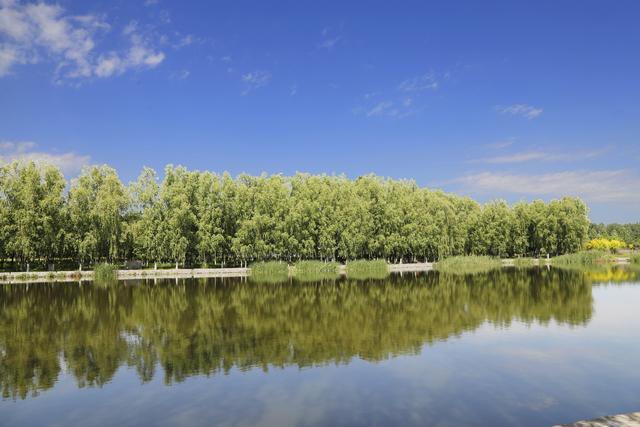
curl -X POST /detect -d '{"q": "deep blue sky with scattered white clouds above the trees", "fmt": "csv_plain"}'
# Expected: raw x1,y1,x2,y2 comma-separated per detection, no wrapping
0,0,640,222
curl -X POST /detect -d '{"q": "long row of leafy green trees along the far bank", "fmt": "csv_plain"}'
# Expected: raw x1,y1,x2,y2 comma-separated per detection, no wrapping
0,162,589,267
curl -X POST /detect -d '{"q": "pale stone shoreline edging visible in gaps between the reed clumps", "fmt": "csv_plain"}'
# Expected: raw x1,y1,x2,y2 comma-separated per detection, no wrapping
0,258,630,285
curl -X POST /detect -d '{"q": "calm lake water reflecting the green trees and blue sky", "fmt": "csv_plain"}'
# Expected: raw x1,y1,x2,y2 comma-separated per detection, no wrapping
0,269,640,427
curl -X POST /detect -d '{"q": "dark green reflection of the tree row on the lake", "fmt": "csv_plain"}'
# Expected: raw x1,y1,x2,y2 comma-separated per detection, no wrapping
0,269,592,399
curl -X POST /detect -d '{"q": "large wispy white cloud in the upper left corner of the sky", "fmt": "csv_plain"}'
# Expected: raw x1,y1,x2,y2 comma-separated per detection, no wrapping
0,0,164,82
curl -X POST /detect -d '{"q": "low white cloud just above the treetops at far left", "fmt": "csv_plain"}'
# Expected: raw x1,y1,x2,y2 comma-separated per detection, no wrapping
0,141,91,174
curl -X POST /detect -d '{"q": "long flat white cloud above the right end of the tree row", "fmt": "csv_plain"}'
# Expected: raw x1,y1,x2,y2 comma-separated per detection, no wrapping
453,169,640,202
